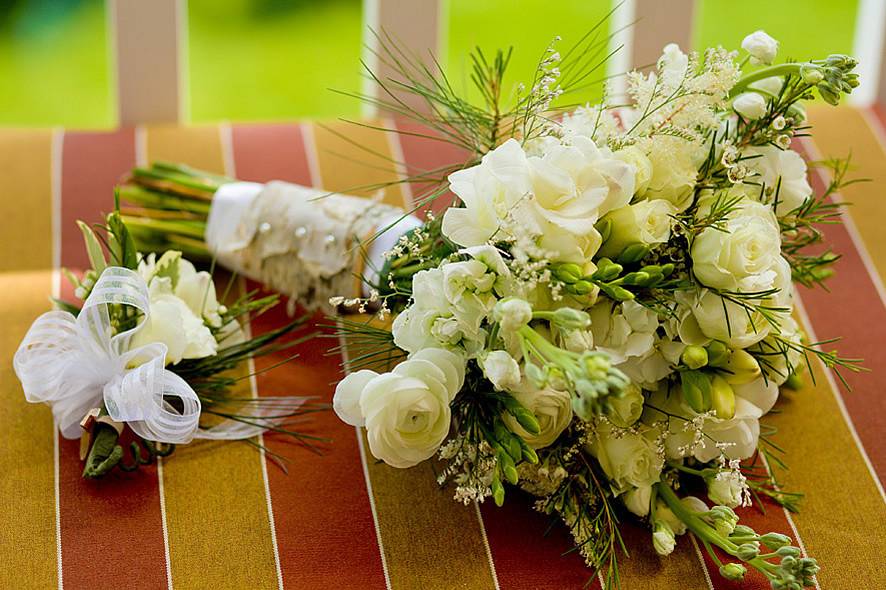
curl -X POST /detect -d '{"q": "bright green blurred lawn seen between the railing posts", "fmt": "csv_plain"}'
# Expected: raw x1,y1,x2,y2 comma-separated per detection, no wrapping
0,0,858,128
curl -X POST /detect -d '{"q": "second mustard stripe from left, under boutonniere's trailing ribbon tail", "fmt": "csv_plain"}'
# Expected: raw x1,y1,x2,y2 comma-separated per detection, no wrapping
146,127,278,590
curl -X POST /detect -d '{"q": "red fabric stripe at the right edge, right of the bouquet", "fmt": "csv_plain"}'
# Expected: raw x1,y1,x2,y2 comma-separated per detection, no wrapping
797,143,886,482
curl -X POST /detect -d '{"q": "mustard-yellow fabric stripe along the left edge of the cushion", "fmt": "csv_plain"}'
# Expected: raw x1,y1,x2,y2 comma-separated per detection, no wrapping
0,131,59,588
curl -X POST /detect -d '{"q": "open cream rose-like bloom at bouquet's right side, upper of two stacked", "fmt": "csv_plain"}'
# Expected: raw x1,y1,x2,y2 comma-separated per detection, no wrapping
691,199,782,293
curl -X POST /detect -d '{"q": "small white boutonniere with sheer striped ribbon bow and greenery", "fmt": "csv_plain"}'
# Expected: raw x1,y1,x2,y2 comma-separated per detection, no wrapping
13,206,313,478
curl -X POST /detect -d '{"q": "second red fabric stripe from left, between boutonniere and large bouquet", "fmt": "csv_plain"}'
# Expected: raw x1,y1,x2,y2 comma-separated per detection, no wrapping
233,125,385,589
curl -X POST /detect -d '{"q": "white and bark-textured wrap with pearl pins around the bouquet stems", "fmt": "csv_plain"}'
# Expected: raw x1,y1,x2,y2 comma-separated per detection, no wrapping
206,181,421,311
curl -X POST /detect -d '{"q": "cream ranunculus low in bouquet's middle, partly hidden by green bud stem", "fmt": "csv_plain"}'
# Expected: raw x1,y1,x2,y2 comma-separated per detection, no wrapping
502,382,572,449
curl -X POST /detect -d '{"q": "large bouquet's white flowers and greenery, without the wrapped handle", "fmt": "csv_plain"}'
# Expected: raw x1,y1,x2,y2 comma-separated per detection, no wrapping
332,27,858,589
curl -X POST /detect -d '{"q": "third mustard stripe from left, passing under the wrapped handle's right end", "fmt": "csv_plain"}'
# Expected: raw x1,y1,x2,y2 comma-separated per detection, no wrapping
308,123,496,590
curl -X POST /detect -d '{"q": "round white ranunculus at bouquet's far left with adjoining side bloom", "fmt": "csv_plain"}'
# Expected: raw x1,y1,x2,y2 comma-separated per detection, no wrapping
333,349,464,468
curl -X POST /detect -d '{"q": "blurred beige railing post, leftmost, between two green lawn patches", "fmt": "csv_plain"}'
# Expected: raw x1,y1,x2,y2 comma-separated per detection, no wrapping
108,0,188,125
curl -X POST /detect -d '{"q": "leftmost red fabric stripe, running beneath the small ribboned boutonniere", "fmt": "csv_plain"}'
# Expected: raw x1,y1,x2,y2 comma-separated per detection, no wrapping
59,130,166,588
